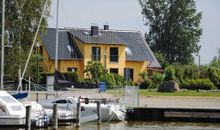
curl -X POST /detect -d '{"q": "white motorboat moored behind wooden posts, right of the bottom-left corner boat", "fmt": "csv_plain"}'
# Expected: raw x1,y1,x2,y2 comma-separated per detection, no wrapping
39,97,125,122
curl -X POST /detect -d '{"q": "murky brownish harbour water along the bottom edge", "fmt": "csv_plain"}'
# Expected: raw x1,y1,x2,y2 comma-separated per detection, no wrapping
43,121,220,130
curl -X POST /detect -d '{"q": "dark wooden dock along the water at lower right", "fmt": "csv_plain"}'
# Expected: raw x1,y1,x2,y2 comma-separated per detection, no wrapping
126,107,220,123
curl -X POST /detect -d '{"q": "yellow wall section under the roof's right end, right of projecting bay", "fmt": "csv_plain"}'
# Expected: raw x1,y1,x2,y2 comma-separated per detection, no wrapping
126,61,149,82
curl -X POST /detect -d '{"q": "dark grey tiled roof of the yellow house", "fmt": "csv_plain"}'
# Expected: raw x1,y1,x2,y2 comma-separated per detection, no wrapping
41,28,161,68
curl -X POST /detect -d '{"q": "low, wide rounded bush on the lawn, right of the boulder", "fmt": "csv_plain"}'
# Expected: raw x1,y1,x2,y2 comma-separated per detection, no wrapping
180,79,216,90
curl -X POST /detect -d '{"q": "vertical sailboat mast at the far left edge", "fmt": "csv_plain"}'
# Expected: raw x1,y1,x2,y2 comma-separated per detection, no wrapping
1,0,5,90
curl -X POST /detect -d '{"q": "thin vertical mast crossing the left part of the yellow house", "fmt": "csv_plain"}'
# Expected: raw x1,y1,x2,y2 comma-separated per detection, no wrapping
55,0,59,70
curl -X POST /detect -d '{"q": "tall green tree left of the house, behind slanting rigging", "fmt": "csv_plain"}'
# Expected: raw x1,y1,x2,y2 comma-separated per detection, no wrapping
0,0,51,81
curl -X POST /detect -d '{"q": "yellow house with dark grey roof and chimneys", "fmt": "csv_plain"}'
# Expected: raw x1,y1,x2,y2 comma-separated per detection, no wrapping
39,25,161,81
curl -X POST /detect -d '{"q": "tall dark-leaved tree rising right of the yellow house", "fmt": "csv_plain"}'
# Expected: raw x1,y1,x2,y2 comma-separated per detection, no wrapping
139,0,202,64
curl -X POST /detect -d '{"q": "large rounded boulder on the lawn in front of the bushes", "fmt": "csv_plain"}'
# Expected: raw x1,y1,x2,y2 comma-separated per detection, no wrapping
157,81,180,92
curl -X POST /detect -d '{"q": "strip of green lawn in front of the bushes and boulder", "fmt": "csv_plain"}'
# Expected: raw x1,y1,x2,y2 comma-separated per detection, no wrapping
107,89,220,97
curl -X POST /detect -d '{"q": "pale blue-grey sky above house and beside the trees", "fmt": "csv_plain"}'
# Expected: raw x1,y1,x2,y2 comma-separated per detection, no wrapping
48,0,220,64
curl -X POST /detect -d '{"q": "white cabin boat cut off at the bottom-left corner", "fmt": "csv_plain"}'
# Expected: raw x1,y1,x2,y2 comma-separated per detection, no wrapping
0,91,26,125
